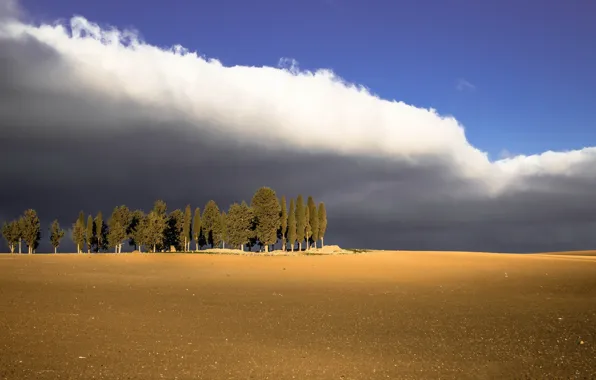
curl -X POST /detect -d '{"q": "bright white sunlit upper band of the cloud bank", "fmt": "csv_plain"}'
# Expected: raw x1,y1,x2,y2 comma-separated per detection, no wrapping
0,5,596,196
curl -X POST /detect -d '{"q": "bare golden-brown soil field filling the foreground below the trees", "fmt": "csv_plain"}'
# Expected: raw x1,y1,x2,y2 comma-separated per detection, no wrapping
0,251,596,380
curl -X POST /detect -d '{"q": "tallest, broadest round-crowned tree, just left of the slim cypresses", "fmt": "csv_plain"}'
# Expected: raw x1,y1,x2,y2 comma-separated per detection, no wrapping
251,187,281,252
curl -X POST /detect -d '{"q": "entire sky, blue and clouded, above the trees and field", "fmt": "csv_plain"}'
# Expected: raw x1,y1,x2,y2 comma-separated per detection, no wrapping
0,0,596,252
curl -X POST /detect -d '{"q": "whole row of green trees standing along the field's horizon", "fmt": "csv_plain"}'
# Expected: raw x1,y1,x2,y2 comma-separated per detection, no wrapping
2,187,327,254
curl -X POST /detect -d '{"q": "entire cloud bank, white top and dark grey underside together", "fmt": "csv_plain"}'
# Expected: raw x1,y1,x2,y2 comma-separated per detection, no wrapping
0,5,596,251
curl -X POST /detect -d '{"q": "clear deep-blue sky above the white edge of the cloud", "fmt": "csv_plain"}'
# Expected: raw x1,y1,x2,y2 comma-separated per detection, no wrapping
22,0,596,158
